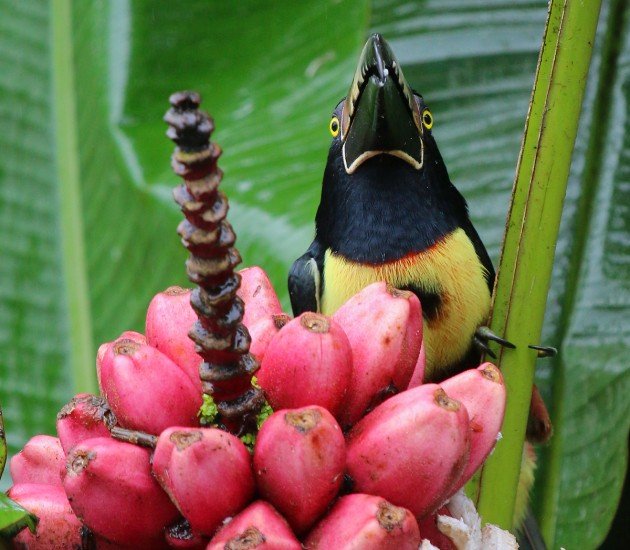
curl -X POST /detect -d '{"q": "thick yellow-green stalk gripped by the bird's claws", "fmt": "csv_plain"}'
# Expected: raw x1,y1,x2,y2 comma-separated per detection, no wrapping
478,0,601,529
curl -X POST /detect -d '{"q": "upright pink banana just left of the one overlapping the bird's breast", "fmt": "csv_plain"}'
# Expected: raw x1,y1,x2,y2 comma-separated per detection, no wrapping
257,312,352,416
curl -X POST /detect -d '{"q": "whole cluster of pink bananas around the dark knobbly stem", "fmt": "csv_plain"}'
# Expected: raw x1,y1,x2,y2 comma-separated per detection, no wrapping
4,267,505,550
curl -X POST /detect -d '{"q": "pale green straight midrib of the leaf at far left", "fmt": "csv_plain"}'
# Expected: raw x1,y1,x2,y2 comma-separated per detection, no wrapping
50,0,96,392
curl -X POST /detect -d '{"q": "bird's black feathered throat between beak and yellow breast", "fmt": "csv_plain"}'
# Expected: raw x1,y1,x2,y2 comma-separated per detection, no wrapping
316,154,467,264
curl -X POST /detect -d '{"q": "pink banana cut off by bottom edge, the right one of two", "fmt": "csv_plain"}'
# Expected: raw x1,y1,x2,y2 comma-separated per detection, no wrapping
304,494,420,550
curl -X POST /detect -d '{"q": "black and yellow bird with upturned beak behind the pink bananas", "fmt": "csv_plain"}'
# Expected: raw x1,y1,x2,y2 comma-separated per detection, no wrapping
288,34,511,381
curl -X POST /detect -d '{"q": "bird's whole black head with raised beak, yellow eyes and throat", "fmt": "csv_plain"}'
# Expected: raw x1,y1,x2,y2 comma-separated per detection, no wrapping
315,34,467,263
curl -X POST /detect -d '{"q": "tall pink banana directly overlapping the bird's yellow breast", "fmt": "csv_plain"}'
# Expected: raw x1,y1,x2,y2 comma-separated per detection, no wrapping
333,282,422,429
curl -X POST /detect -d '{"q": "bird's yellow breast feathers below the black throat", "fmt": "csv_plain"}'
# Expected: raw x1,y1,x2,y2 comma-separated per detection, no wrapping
321,229,490,380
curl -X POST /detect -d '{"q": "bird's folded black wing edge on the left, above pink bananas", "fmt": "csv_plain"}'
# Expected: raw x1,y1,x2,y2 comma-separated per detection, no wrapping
289,239,325,317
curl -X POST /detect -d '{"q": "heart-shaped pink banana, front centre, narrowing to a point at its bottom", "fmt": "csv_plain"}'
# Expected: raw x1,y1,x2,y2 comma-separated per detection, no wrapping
254,406,346,535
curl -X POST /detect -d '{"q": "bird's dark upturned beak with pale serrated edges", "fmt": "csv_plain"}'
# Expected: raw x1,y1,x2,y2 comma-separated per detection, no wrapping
341,34,423,174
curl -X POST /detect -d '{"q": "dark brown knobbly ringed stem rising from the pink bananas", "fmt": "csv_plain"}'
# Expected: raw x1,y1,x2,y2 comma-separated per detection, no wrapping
164,92,264,435
